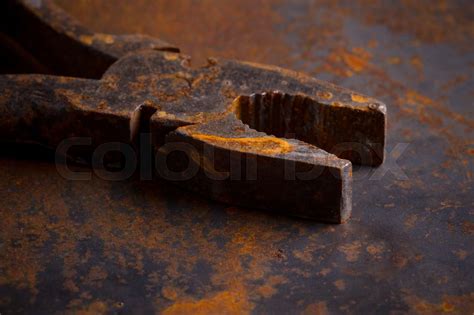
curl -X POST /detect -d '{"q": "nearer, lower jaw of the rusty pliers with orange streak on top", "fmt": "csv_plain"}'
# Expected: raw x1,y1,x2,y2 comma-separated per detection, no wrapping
161,115,352,223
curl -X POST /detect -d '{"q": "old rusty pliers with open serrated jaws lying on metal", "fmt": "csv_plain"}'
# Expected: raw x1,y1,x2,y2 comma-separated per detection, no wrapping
0,1,386,223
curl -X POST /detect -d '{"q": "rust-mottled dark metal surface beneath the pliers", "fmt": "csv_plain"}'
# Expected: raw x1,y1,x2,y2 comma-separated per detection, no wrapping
0,0,474,314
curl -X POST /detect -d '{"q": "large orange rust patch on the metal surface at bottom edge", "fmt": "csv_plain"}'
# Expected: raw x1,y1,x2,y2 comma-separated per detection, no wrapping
163,291,250,315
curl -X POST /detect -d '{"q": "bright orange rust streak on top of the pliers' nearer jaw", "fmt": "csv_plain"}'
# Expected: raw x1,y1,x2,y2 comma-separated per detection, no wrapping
193,134,293,155
